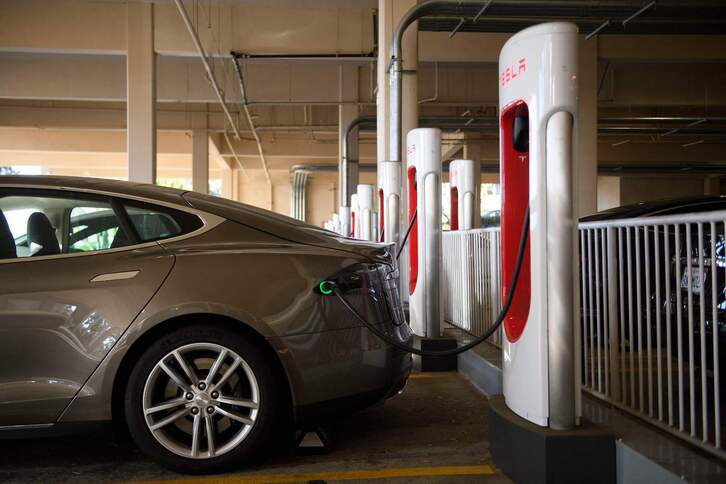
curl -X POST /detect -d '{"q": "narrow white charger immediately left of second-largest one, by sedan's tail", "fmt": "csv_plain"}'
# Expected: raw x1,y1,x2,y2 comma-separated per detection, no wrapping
378,161,401,244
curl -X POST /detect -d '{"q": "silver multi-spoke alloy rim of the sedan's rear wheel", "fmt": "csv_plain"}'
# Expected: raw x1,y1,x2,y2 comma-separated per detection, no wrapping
142,342,260,459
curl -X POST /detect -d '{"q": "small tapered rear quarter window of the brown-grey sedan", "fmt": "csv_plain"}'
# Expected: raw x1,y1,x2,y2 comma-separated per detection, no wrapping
124,203,202,242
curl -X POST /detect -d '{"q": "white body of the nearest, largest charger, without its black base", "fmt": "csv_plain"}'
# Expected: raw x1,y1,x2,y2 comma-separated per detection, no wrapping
499,23,579,429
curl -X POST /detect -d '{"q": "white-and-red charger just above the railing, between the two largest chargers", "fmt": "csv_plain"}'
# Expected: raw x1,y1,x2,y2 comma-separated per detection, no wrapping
449,160,479,230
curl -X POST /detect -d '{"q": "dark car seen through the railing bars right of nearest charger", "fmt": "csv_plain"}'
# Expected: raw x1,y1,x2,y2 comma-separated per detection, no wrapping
580,196,726,407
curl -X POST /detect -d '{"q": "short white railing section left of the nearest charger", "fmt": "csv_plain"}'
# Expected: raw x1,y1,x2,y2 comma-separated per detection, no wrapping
443,229,501,344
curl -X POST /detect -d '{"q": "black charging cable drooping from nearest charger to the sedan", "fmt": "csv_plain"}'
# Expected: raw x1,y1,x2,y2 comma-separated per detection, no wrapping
329,207,529,356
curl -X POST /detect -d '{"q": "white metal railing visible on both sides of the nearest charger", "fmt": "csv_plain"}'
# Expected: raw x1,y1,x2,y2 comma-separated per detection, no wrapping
443,211,726,459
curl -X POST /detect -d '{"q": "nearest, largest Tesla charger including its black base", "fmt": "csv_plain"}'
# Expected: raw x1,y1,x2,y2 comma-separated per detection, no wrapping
490,23,615,482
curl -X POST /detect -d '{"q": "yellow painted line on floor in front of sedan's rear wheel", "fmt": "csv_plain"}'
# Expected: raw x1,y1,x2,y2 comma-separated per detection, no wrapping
137,465,496,484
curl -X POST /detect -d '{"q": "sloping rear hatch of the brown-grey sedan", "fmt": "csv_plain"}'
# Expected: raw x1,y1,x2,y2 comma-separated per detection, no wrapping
183,192,393,262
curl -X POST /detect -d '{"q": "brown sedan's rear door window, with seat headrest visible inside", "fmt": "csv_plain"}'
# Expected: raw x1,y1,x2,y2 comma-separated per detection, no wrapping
0,188,131,259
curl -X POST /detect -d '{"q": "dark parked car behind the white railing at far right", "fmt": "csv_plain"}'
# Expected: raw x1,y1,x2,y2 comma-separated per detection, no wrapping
580,196,726,403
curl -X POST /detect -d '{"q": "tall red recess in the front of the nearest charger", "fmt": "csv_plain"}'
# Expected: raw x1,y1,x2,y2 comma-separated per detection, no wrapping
499,101,531,342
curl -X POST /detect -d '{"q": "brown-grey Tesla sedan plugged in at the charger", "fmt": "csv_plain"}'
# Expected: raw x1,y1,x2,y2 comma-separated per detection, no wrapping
0,176,411,472
